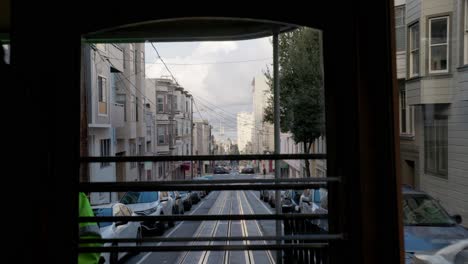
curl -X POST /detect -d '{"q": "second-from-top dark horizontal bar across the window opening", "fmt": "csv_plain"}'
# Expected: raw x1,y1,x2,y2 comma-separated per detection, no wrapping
78,181,327,192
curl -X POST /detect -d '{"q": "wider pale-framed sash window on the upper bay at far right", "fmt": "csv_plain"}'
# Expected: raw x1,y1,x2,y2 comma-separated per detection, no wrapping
429,16,449,73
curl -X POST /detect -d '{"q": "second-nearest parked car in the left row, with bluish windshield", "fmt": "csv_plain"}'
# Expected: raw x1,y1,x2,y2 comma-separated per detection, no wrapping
120,192,174,234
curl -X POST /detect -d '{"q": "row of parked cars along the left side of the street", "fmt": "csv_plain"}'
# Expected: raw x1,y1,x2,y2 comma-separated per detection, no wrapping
92,176,211,264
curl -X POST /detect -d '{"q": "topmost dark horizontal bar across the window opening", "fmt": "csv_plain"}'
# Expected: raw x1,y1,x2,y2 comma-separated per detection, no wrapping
80,153,327,163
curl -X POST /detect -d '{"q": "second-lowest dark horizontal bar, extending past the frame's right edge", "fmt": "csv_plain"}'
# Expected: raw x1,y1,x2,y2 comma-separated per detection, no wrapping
78,234,343,244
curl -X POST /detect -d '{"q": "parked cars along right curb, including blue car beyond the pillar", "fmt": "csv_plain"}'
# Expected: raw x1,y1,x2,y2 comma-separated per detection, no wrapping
260,186,468,264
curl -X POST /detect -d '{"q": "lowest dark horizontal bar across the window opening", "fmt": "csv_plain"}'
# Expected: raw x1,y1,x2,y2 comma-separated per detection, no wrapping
78,243,328,253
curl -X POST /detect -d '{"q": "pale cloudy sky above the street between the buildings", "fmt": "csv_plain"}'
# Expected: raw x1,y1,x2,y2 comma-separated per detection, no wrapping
145,38,273,140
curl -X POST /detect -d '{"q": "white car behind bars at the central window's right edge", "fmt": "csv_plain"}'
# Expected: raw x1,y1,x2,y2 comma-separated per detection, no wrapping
299,188,328,231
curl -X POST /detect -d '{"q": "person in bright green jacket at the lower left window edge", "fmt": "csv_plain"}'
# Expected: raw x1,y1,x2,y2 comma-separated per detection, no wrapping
78,192,102,264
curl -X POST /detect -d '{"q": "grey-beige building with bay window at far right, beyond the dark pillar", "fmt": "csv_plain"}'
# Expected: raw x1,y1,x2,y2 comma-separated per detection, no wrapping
395,0,468,225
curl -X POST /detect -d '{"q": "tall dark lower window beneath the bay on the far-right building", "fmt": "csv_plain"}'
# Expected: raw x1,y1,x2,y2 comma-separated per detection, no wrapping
423,105,448,178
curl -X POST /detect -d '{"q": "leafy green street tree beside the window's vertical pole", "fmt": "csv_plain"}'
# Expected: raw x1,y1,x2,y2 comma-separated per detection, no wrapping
264,28,325,177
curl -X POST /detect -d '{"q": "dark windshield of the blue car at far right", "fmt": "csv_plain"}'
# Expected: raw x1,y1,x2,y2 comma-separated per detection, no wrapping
403,194,455,226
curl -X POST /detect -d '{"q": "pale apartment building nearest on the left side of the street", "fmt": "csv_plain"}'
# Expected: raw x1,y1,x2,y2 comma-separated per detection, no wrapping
83,44,147,204
